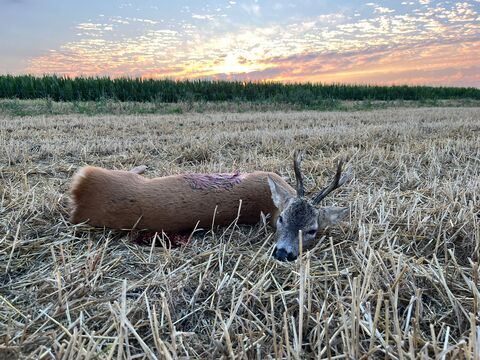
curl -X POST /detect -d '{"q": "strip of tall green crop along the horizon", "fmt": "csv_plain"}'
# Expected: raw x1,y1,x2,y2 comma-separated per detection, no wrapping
0,75,480,107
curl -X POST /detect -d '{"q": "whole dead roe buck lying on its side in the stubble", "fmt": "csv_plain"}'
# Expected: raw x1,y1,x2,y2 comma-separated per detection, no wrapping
71,152,350,261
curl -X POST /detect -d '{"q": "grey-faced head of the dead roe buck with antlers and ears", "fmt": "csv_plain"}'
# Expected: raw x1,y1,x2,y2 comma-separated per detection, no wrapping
268,151,351,261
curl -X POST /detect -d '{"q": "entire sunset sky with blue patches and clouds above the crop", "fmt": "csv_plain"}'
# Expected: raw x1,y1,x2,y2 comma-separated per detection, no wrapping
0,0,480,87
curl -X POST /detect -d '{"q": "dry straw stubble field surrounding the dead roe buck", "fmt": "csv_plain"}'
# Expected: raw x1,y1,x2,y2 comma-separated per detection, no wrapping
0,108,480,359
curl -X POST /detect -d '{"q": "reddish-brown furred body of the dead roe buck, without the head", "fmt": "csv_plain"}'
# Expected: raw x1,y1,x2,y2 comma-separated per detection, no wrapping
71,166,295,232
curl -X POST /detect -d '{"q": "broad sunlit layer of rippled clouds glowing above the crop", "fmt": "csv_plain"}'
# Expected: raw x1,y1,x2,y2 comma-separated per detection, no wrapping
28,2,480,86
